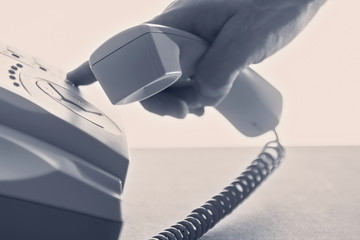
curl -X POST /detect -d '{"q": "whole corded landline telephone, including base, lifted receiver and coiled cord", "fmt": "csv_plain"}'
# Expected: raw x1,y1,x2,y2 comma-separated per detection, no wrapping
0,24,283,240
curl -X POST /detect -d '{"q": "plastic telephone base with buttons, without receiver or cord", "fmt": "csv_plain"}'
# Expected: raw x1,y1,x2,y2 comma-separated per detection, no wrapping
0,45,129,240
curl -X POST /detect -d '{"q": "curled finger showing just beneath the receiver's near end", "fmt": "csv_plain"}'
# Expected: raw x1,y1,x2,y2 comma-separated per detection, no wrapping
140,91,189,118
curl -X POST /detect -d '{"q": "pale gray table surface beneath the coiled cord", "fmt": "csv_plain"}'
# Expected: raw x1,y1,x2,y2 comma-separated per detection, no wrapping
120,147,360,240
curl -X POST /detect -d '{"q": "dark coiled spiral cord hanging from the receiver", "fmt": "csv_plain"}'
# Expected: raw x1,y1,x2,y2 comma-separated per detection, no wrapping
150,131,285,240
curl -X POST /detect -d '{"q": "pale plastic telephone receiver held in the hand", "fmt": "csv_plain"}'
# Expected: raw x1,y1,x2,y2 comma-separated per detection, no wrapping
68,23,282,137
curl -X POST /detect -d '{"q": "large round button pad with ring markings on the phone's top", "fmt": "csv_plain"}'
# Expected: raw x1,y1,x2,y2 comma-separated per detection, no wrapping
19,71,122,135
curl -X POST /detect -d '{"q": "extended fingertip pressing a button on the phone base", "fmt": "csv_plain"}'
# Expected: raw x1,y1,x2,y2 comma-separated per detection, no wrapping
66,61,96,86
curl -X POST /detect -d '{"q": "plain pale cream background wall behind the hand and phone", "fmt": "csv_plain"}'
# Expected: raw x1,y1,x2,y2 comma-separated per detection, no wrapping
0,0,360,147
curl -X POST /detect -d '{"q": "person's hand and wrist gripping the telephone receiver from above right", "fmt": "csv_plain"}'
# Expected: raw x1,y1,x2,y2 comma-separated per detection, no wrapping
141,0,326,118
